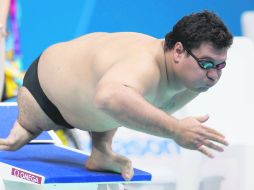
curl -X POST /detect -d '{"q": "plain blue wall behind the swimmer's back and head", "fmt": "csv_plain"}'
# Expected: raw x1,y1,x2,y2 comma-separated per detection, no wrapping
19,0,254,69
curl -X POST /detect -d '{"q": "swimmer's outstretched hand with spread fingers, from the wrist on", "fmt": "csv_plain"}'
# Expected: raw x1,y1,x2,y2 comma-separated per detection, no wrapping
173,115,228,158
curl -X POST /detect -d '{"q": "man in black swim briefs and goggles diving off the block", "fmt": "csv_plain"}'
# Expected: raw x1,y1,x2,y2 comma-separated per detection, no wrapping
0,11,232,180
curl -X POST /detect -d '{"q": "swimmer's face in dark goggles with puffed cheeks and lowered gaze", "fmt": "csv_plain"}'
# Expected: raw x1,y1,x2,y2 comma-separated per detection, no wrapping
178,43,227,92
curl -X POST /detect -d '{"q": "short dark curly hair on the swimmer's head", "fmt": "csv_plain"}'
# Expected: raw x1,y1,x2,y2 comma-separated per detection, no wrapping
165,10,233,49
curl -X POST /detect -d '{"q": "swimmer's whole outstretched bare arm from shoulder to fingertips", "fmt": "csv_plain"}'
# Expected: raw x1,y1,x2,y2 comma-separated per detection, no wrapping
95,57,227,157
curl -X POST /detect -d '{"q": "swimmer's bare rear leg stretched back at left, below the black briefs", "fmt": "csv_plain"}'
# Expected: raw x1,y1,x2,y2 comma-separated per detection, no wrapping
0,87,56,151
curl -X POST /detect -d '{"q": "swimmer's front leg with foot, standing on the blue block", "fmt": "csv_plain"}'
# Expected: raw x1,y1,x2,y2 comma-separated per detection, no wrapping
86,129,133,180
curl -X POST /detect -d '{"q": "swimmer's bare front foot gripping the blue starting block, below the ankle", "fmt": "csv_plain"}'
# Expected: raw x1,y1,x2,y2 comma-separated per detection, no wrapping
85,148,134,180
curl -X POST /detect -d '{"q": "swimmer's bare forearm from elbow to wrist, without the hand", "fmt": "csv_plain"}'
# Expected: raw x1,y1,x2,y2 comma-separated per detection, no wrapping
95,83,178,138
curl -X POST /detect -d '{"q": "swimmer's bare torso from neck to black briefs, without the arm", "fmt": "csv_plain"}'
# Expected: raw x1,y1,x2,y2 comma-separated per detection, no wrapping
34,33,194,131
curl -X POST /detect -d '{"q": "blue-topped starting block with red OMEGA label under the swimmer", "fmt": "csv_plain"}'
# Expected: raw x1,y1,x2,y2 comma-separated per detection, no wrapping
0,103,151,190
